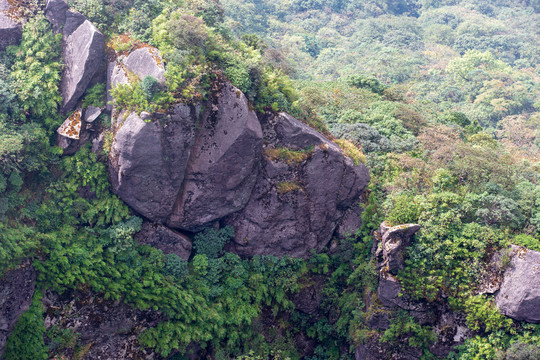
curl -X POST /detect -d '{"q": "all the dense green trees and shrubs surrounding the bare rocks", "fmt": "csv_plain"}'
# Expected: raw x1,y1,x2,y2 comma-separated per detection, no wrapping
0,0,540,360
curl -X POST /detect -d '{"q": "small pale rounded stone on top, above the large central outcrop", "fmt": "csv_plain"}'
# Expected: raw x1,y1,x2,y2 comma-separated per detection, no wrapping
123,46,165,85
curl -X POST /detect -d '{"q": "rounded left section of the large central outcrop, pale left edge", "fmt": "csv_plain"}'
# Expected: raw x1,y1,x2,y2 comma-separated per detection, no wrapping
109,105,197,223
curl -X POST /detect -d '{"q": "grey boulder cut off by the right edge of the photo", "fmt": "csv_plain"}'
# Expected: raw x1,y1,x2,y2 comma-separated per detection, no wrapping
495,246,540,323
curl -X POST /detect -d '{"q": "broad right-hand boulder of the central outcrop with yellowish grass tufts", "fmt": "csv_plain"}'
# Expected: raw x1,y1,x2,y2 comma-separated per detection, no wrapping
225,113,369,257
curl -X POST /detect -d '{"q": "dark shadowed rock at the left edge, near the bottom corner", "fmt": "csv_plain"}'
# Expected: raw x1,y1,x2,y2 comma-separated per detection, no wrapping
0,261,36,357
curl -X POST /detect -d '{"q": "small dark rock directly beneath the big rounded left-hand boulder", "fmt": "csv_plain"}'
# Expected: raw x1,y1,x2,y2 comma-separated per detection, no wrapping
135,221,192,261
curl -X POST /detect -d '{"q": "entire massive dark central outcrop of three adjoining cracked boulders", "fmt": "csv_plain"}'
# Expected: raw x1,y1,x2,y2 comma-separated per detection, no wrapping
109,46,369,257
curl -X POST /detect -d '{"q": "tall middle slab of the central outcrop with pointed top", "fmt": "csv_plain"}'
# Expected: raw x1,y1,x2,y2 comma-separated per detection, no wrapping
168,83,262,231
